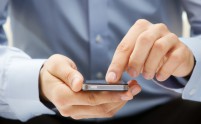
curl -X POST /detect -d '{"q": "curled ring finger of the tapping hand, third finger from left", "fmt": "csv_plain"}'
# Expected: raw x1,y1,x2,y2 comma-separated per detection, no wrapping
143,33,178,79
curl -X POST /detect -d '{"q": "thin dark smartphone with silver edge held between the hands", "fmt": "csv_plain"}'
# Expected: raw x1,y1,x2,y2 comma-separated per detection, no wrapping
82,80,129,91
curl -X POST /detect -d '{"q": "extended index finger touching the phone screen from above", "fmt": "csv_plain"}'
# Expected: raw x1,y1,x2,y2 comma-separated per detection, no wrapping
106,19,151,83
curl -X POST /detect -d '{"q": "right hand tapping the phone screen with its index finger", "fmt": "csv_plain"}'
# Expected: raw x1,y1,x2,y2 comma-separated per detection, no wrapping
106,19,194,83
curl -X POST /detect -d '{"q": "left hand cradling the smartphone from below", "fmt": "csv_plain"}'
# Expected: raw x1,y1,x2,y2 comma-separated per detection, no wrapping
39,54,141,119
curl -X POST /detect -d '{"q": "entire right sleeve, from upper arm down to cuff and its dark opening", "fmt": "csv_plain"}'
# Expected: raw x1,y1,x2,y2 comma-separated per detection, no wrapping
157,0,201,102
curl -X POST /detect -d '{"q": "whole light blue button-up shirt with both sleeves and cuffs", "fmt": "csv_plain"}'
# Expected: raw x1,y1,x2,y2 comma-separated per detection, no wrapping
0,0,201,121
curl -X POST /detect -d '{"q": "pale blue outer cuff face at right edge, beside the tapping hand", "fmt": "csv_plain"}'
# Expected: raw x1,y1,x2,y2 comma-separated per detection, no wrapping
181,36,201,102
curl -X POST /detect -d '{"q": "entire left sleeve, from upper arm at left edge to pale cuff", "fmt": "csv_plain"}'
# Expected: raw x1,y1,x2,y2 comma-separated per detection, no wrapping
0,0,54,121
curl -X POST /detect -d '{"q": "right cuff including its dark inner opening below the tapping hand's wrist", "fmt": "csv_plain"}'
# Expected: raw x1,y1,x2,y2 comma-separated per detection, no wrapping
153,37,201,102
